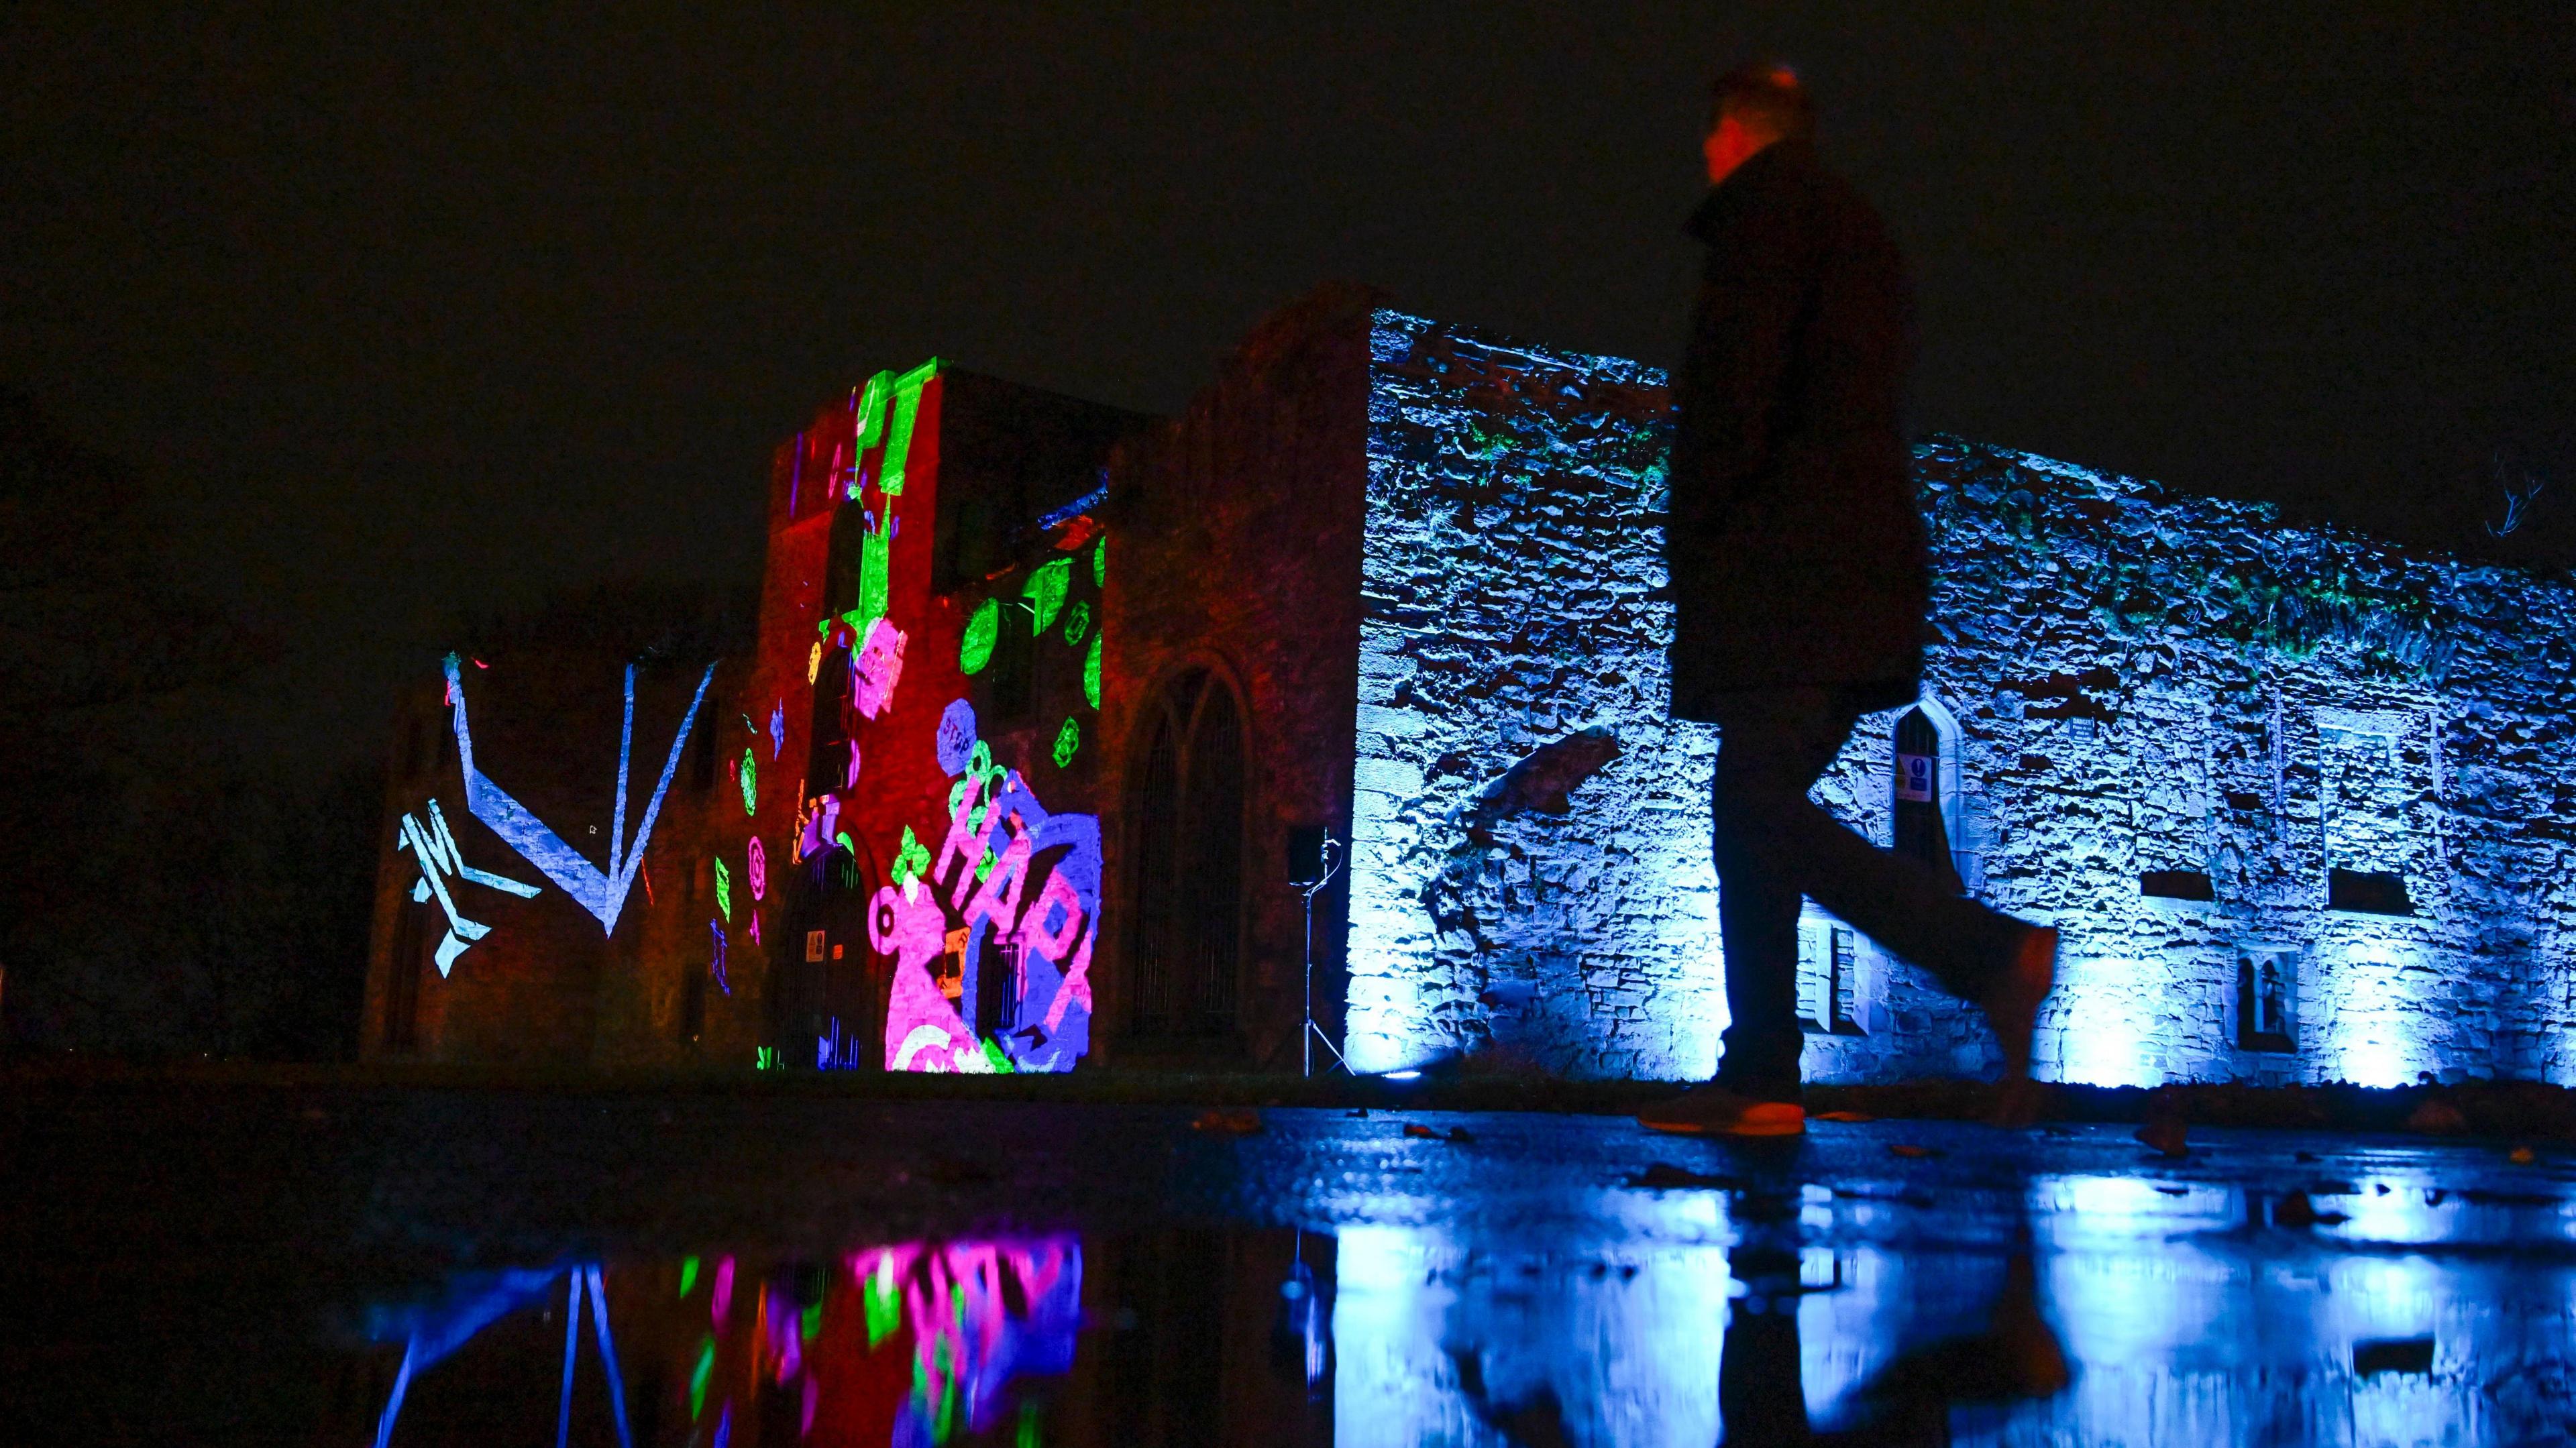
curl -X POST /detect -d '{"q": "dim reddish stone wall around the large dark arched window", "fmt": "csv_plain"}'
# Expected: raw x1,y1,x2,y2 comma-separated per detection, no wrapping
1097,286,1373,1069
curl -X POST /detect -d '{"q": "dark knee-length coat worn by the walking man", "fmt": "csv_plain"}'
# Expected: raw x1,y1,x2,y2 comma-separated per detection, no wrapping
1664,142,1929,719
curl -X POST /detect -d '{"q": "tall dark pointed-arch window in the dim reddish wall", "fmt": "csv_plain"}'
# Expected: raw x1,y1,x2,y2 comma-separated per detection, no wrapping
1128,670,1244,1036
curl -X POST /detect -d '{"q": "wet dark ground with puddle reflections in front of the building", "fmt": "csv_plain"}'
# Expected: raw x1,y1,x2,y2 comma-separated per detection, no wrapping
0,1087,2576,1448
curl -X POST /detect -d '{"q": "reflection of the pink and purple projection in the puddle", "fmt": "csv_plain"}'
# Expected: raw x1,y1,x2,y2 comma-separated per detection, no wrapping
850,1237,1082,1443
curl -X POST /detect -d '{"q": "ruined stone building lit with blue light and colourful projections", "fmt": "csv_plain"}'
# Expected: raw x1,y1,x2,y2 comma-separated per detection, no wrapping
368,288,2576,1084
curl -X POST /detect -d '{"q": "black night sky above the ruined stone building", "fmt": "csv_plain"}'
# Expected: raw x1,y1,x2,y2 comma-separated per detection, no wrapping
0,0,2576,753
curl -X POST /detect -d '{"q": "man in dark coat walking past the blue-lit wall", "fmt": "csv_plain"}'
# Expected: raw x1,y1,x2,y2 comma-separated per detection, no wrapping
1638,67,2058,1136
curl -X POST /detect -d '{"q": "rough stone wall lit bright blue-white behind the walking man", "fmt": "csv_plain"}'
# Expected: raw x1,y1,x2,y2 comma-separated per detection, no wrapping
1347,312,2576,1084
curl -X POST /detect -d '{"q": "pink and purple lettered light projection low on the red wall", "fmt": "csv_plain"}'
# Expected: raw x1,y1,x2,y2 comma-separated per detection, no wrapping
868,698,1100,1074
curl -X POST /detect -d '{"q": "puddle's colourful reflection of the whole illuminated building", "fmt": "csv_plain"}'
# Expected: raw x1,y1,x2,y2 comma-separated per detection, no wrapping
343,1139,2576,1448
